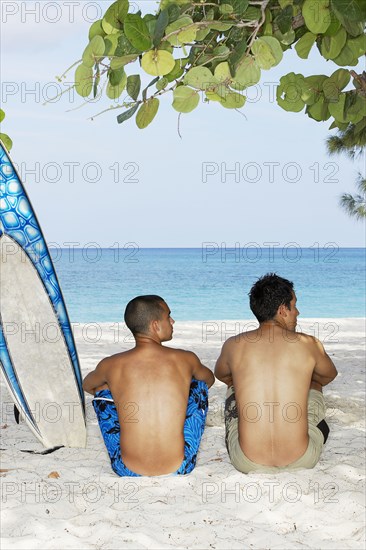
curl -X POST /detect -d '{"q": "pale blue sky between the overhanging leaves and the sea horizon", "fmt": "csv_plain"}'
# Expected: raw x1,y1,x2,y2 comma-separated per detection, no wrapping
1,0,365,248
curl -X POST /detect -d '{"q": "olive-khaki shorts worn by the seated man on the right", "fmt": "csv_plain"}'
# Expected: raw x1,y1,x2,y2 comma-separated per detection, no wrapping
225,386,325,474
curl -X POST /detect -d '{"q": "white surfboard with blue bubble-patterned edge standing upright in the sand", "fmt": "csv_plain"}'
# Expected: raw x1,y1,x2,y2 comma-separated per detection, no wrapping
0,141,86,447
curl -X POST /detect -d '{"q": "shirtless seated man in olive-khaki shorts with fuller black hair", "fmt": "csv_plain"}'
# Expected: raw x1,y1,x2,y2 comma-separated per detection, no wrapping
215,274,337,473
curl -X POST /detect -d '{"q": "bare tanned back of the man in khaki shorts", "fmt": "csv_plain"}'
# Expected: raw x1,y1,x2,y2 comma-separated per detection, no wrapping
219,325,322,466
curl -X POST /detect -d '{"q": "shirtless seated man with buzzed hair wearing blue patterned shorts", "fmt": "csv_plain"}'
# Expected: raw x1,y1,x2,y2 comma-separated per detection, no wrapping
83,295,215,476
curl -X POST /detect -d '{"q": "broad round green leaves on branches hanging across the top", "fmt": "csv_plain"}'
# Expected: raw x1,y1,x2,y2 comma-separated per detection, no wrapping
60,0,366,132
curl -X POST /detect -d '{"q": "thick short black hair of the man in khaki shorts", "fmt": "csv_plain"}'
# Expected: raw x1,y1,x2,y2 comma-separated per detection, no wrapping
249,273,294,323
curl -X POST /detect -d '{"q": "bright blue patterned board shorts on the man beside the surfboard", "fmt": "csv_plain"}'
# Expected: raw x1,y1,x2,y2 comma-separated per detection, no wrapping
93,379,208,477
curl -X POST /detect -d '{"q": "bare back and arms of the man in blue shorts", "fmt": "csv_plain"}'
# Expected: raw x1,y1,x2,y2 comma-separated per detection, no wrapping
83,337,214,475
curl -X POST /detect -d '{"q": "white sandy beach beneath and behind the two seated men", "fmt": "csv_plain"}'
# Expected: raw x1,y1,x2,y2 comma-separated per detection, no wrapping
0,319,365,550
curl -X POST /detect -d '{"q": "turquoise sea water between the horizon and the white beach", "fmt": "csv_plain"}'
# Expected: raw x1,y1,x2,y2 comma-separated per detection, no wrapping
51,244,366,322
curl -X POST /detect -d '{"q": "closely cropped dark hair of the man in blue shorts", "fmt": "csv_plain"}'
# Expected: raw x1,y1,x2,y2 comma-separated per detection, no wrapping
125,294,164,334
